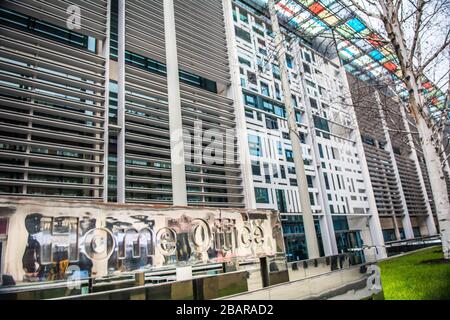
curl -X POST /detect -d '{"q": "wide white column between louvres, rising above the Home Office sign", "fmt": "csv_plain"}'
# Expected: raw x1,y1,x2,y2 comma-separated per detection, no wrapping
164,0,187,206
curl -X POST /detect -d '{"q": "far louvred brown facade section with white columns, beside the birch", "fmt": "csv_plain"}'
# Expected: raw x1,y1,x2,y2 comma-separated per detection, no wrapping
348,75,437,242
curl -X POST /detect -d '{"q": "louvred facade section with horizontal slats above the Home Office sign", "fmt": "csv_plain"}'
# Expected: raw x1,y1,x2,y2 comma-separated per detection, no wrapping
0,0,244,207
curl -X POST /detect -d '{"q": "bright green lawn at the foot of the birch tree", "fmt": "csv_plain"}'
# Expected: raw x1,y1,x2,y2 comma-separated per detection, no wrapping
379,247,450,300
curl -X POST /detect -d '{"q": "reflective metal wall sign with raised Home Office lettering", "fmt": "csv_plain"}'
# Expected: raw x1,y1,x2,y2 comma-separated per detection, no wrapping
1,201,284,282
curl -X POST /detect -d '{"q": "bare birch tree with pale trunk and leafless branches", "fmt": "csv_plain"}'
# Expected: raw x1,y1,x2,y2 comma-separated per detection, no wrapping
347,0,450,259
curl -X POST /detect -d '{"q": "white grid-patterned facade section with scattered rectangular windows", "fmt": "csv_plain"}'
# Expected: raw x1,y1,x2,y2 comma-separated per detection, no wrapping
227,1,384,261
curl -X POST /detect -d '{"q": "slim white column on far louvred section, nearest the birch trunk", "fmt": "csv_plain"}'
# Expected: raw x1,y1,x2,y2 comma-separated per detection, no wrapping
400,104,437,238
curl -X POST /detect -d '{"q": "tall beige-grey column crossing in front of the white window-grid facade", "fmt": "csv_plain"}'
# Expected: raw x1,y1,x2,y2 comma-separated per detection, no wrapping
269,0,320,259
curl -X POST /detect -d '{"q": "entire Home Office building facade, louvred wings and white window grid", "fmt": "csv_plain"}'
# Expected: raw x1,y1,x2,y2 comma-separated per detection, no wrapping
0,0,442,280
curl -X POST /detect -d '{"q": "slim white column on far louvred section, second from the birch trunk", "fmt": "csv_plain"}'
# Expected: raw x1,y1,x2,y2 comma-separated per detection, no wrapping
375,91,414,240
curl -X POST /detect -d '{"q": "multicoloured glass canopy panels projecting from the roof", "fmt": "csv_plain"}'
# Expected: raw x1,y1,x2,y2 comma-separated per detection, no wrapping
249,0,445,113
